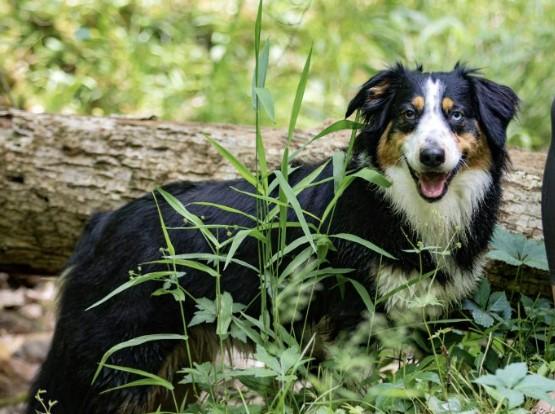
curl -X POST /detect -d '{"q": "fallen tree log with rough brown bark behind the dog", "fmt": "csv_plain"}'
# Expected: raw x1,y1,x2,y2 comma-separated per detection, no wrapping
0,110,549,294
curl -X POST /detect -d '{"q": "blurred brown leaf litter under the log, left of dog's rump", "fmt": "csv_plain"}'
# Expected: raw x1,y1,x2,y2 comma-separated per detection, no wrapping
0,272,57,414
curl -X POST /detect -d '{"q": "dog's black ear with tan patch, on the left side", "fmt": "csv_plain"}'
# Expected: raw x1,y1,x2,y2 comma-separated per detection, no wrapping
345,64,405,128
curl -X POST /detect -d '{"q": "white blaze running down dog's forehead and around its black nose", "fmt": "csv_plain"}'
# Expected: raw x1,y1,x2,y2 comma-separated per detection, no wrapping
403,77,461,172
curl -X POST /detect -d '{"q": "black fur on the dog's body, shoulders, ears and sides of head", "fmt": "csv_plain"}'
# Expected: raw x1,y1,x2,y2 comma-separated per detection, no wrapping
27,65,517,414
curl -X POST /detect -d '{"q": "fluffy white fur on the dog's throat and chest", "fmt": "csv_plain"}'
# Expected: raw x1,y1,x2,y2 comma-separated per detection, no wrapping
372,161,491,317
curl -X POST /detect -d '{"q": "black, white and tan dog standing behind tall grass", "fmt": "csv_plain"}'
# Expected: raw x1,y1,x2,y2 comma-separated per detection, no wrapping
27,64,519,414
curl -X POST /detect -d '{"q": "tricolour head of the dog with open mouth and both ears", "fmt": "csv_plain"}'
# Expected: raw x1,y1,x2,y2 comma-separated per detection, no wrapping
346,64,518,202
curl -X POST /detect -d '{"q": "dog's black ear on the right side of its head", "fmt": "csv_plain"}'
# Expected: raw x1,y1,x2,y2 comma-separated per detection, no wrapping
470,76,519,148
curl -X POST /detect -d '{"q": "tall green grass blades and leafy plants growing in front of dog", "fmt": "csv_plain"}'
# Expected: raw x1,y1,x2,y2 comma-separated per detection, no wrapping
39,1,555,414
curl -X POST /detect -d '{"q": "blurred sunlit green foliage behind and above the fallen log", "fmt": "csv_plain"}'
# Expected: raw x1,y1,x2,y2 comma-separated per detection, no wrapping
0,0,555,148
